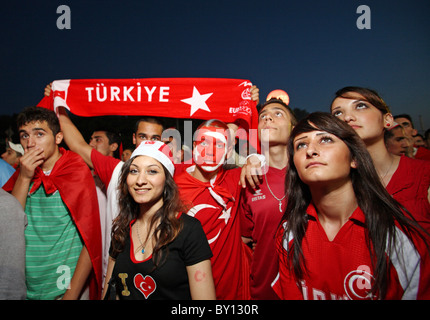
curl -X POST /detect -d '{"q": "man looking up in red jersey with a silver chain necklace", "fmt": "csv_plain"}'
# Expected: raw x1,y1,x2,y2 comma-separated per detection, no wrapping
239,98,297,300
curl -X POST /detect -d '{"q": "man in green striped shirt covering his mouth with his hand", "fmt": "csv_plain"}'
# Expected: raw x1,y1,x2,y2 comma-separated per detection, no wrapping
3,107,101,300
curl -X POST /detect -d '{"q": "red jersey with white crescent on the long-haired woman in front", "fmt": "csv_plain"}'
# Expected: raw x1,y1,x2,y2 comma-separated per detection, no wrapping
273,205,430,300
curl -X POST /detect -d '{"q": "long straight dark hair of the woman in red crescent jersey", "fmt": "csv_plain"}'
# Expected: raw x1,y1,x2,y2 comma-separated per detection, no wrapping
282,112,423,298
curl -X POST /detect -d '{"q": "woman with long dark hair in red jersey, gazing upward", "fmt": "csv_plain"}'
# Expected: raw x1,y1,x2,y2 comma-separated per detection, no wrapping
273,112,430,299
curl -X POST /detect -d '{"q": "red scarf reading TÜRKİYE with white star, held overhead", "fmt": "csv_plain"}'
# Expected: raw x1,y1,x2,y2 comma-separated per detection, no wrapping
38,78,258,129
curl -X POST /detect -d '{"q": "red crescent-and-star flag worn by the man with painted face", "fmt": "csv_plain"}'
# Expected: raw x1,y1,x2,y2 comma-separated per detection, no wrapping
175,166,249,300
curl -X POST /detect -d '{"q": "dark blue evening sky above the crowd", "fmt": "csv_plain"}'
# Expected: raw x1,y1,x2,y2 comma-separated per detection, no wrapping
0,0,430,130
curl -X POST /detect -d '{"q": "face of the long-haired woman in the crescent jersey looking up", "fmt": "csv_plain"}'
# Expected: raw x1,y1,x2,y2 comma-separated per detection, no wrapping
293,129,356,185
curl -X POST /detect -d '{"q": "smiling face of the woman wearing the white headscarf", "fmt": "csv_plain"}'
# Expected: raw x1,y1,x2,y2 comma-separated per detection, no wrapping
127,156,166,204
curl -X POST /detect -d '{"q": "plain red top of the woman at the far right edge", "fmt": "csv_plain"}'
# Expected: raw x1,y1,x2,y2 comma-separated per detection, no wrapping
386,156,430,232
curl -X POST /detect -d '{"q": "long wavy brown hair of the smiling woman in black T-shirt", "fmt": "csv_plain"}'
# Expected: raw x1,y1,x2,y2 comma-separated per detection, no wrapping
110,157,183,267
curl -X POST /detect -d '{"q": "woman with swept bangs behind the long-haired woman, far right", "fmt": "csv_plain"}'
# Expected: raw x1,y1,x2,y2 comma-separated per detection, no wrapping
330,87,430,232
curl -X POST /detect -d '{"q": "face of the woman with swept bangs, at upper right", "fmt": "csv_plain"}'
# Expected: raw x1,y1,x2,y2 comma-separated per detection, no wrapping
331,93,393,142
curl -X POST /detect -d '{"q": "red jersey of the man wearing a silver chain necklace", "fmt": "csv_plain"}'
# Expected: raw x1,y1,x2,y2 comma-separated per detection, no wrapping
239,167,287,300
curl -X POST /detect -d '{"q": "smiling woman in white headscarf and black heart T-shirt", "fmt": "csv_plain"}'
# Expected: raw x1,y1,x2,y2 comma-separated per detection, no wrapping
104,141,215,300
